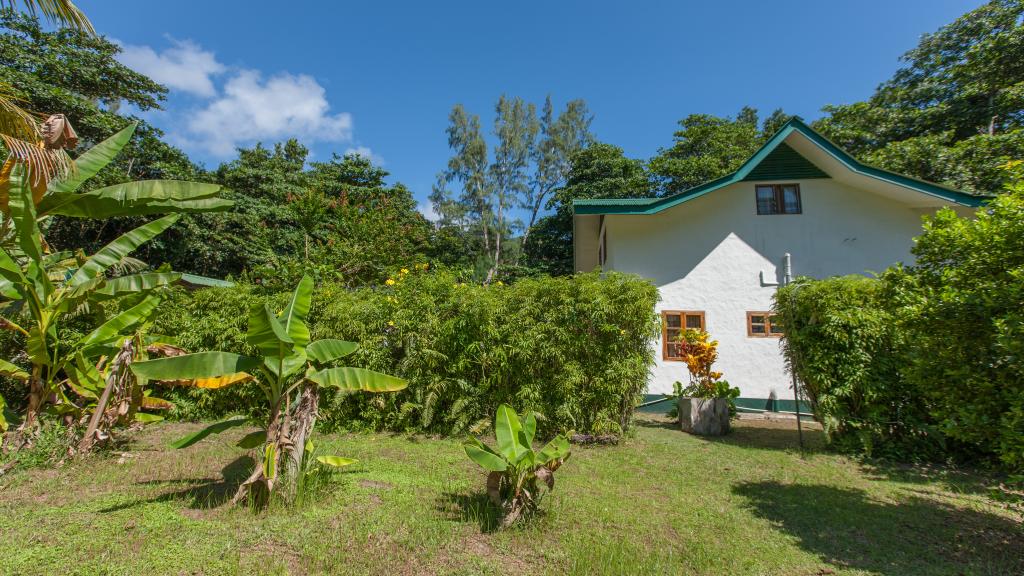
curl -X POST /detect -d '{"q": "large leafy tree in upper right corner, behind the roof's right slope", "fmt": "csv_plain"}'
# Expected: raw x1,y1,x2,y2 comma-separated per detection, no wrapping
815,0,1024,193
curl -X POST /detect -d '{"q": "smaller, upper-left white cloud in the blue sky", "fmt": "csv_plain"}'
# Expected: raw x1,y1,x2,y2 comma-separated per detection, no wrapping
117,40,225,97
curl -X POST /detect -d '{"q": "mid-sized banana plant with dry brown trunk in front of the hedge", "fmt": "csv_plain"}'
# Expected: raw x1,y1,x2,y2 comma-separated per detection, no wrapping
131,276,407,506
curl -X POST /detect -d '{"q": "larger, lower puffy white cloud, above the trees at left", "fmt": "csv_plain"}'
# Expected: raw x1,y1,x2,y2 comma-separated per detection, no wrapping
186,70,352,156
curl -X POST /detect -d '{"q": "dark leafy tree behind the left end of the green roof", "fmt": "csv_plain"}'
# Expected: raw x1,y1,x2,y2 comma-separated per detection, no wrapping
525,142,654,275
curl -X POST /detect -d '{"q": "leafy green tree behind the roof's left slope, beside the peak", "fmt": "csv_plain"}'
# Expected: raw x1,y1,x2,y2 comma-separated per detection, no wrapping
650,107,791,195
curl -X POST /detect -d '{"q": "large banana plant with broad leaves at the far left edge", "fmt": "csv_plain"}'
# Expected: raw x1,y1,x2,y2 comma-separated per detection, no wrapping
0,125,231,448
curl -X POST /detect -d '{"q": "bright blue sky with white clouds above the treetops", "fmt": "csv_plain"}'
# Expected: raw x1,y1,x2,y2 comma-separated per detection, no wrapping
79,0,982,218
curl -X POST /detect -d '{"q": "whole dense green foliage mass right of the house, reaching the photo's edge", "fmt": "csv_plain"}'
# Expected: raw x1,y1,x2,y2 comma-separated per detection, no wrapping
776,170,1024,470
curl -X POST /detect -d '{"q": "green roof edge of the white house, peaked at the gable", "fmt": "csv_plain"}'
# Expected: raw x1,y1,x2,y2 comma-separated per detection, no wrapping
572,118,985,214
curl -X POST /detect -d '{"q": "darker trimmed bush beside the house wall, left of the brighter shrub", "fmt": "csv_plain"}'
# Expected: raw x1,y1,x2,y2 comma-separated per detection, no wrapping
774,276,942,457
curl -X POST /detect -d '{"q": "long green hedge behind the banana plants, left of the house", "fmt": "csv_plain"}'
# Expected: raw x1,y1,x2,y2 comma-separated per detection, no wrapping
155,271,657,434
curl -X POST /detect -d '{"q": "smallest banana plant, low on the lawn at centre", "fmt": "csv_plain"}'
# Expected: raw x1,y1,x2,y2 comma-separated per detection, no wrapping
463,404,569,528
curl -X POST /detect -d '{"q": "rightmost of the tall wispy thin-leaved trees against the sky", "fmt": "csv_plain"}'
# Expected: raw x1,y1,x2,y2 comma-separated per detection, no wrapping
520,95,594,249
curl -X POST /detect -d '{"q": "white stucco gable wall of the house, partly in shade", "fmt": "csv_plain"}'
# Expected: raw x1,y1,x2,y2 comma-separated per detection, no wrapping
604,179,958,399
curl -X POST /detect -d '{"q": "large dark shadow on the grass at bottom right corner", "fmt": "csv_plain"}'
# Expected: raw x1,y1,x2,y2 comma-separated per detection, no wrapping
732,482,1024,576
